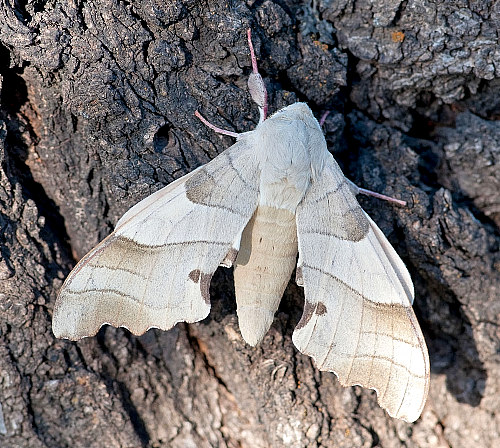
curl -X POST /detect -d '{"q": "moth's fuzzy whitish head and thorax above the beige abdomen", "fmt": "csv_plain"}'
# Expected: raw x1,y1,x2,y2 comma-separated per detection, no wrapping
252,103,328,213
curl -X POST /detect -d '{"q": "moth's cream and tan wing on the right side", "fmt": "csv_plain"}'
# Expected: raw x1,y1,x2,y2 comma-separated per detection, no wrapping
293,158,429,422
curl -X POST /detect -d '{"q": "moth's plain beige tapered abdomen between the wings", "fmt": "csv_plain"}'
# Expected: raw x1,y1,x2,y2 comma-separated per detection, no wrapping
234,205,297,345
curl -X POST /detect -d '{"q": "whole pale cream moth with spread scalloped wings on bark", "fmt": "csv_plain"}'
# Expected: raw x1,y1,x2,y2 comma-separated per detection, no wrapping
52,31,429,422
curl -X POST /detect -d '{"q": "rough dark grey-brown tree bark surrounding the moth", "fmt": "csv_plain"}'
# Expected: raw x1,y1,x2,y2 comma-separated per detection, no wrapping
0,0,500,448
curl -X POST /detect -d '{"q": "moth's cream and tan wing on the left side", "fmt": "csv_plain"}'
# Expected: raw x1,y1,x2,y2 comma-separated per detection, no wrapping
52,139,259,340
